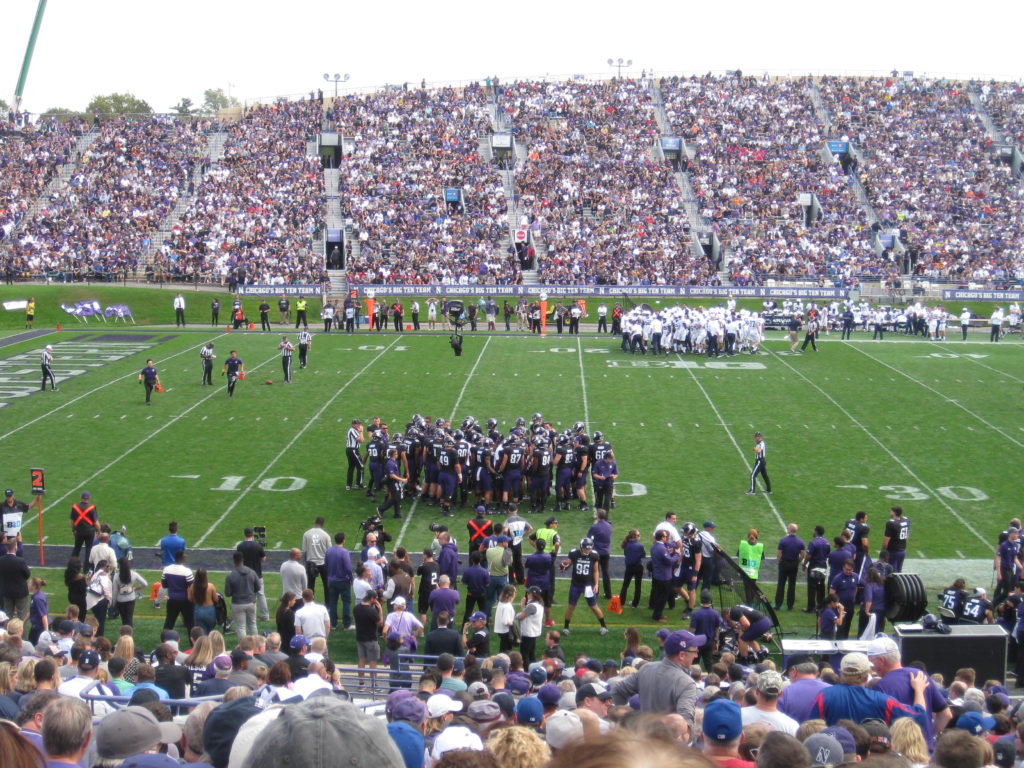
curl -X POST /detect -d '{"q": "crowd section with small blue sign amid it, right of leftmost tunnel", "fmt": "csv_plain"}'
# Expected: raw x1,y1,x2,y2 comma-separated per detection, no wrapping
331,85,520,285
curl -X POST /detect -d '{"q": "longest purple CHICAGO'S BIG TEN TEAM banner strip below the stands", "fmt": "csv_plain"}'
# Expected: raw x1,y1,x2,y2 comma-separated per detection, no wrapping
346,284,849,299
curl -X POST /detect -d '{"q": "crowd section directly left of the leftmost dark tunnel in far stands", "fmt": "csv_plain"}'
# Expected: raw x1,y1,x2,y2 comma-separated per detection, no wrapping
155,100,326,285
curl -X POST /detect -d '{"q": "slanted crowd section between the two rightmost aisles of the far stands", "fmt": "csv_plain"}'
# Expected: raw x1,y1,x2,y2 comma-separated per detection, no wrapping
821,78,1024,283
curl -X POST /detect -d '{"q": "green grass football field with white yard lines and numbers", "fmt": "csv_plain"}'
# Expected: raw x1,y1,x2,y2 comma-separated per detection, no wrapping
0,327,1024,583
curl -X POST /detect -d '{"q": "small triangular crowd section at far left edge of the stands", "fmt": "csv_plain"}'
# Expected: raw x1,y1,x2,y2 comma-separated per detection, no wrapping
0,115,88,250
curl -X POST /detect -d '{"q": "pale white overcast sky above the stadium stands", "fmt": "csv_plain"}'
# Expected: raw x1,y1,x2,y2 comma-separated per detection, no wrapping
0,0,1024,113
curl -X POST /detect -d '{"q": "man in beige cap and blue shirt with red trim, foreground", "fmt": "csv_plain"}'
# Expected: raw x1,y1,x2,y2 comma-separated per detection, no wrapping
811,652,928,730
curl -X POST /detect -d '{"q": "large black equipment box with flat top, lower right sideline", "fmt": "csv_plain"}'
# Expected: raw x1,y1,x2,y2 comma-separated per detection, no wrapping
896,625,1009,685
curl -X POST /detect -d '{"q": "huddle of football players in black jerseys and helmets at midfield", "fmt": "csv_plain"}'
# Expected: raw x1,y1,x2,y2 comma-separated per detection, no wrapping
366,413,618,516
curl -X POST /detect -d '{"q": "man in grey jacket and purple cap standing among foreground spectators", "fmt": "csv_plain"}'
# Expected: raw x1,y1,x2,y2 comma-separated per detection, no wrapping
611,630,708,730
